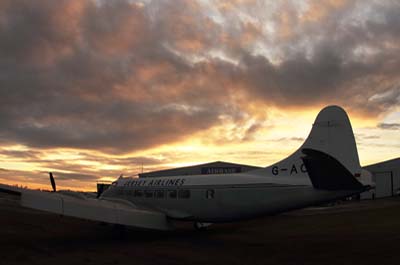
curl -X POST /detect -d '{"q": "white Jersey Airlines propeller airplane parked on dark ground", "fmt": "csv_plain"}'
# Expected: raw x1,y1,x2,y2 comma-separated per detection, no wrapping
0,106,374,230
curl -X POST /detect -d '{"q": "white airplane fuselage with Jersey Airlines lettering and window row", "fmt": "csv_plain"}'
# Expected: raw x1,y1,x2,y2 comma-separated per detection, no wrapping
103,174,357,223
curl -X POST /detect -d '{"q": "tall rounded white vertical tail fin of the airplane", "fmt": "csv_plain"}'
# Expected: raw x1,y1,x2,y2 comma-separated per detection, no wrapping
264,106,361,177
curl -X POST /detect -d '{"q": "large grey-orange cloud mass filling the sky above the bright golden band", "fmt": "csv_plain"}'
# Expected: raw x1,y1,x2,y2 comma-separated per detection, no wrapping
0,0,400,153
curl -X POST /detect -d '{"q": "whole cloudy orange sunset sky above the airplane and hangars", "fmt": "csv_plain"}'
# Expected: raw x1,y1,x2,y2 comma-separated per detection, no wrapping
0,0,400,190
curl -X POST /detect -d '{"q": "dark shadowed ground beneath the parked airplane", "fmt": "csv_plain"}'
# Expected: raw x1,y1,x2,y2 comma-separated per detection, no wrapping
0,192,400,265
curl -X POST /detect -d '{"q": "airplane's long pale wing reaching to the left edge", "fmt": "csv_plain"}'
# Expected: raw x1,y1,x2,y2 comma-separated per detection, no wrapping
0,185,173,230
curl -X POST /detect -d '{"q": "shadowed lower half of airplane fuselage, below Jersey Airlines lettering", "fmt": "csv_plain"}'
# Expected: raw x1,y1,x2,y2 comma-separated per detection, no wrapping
104,184,358,223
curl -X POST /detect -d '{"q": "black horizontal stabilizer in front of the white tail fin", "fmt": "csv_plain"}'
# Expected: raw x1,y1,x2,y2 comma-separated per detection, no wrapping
302,148,365,190
